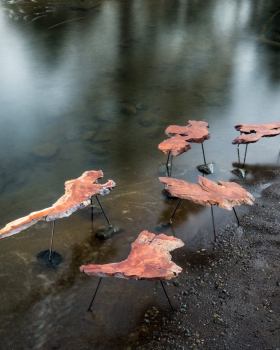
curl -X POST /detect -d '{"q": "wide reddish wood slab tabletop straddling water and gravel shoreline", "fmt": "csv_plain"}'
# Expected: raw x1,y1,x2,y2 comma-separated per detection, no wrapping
159,176,255,210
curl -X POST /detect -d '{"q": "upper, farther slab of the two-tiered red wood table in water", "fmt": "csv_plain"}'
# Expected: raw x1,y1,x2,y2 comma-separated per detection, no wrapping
165,120,210,143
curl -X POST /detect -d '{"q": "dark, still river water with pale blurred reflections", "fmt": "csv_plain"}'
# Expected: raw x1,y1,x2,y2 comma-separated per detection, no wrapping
0,0,280,350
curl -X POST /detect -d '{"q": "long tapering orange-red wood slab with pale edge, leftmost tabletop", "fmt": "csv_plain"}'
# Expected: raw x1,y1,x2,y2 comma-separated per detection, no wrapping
0,170,116,239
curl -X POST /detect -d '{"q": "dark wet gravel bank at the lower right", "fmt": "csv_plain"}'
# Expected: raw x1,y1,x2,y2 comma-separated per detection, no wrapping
127,178,280,350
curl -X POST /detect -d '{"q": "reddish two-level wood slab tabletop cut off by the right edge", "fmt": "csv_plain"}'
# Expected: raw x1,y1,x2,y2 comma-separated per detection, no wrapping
232,122,280,144
